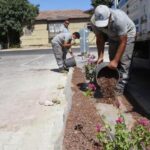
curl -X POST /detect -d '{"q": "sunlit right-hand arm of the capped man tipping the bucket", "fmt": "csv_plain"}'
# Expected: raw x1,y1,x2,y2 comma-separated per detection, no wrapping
108,35,127,69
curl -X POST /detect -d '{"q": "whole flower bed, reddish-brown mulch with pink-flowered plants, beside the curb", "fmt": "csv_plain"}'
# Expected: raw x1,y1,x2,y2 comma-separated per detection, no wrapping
64,68,150,150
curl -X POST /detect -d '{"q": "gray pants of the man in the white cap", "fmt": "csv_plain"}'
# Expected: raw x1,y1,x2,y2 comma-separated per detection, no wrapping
109,38,135,93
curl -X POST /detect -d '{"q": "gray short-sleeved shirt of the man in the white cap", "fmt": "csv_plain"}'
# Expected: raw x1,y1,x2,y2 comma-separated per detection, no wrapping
91,9,136,41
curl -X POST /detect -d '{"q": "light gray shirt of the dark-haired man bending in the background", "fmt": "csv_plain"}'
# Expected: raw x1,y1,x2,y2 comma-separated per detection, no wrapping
52,32,72,46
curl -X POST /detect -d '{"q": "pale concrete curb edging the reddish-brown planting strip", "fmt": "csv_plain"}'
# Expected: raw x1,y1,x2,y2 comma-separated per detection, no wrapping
54,68,74,150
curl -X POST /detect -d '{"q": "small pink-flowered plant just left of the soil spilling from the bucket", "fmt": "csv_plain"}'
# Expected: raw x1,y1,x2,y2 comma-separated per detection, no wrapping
83,83,96,96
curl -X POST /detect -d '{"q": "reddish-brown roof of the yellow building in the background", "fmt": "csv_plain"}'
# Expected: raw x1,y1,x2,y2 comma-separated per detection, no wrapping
36,10,90,21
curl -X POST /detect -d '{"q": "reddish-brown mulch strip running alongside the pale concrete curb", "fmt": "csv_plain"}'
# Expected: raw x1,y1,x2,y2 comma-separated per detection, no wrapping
64,68,102,150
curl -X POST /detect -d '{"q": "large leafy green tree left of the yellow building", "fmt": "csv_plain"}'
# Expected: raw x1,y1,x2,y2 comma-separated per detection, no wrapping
0,0,39,47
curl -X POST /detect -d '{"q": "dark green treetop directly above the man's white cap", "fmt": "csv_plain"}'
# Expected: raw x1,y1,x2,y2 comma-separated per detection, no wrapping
91,0,112,8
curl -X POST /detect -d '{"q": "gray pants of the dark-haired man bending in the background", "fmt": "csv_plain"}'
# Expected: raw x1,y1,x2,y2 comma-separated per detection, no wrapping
52,43,67,68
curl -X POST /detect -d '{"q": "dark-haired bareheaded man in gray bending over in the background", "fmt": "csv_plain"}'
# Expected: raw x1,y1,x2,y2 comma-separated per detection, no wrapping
51,32,80,72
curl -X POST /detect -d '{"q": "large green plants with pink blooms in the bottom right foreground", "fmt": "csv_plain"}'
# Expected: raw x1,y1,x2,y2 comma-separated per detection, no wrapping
96,116,150,150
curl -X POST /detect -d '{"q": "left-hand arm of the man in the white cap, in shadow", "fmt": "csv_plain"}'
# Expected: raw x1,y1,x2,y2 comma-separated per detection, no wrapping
96,34,105,64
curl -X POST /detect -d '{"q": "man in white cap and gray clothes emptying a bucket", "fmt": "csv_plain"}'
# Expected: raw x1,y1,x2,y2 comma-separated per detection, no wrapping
91,5,136,95
